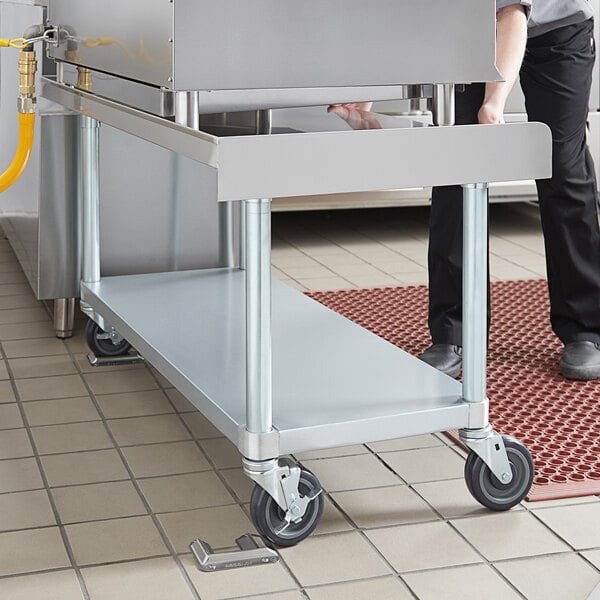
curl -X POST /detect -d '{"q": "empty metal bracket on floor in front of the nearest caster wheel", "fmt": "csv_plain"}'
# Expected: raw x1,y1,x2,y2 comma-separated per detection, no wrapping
190,533,279,572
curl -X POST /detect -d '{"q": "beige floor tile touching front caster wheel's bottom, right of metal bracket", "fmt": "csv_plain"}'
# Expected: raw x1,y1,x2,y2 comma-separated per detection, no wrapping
280,532,390,586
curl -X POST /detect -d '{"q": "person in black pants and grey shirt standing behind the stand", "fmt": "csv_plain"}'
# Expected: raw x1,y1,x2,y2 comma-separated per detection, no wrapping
420,0,600,380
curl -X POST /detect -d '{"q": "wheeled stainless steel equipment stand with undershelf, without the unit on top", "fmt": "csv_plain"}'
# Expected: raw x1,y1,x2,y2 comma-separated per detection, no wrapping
58,77,550,568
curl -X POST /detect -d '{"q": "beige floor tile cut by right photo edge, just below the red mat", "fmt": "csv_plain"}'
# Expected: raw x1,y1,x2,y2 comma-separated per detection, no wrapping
534,502,600,550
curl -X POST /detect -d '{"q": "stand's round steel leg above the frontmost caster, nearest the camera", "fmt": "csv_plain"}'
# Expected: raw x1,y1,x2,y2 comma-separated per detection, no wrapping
245,199,273,433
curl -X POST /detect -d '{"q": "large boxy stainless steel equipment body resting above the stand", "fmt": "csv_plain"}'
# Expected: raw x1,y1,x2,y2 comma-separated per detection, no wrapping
49,0,498,97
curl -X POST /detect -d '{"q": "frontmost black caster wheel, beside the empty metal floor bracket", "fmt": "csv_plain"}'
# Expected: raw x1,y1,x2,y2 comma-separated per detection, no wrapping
250,469,325,547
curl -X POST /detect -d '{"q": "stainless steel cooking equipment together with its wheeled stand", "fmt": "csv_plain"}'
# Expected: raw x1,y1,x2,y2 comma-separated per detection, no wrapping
34,0,550,568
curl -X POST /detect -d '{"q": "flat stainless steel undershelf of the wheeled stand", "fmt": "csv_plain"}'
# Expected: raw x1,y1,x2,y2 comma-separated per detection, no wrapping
82,269,469,453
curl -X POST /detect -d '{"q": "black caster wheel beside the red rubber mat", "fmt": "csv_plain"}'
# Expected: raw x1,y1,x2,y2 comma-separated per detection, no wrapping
465,435,534,510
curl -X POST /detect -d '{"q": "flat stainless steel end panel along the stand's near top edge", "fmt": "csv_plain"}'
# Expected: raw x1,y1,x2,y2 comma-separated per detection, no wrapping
218,118,551,200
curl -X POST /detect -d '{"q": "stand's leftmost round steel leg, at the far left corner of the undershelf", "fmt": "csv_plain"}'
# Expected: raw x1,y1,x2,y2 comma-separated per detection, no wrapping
79,116,102,327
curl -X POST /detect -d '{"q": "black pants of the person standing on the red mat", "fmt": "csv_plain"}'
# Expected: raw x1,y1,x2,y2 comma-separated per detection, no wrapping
428,20,600,345
